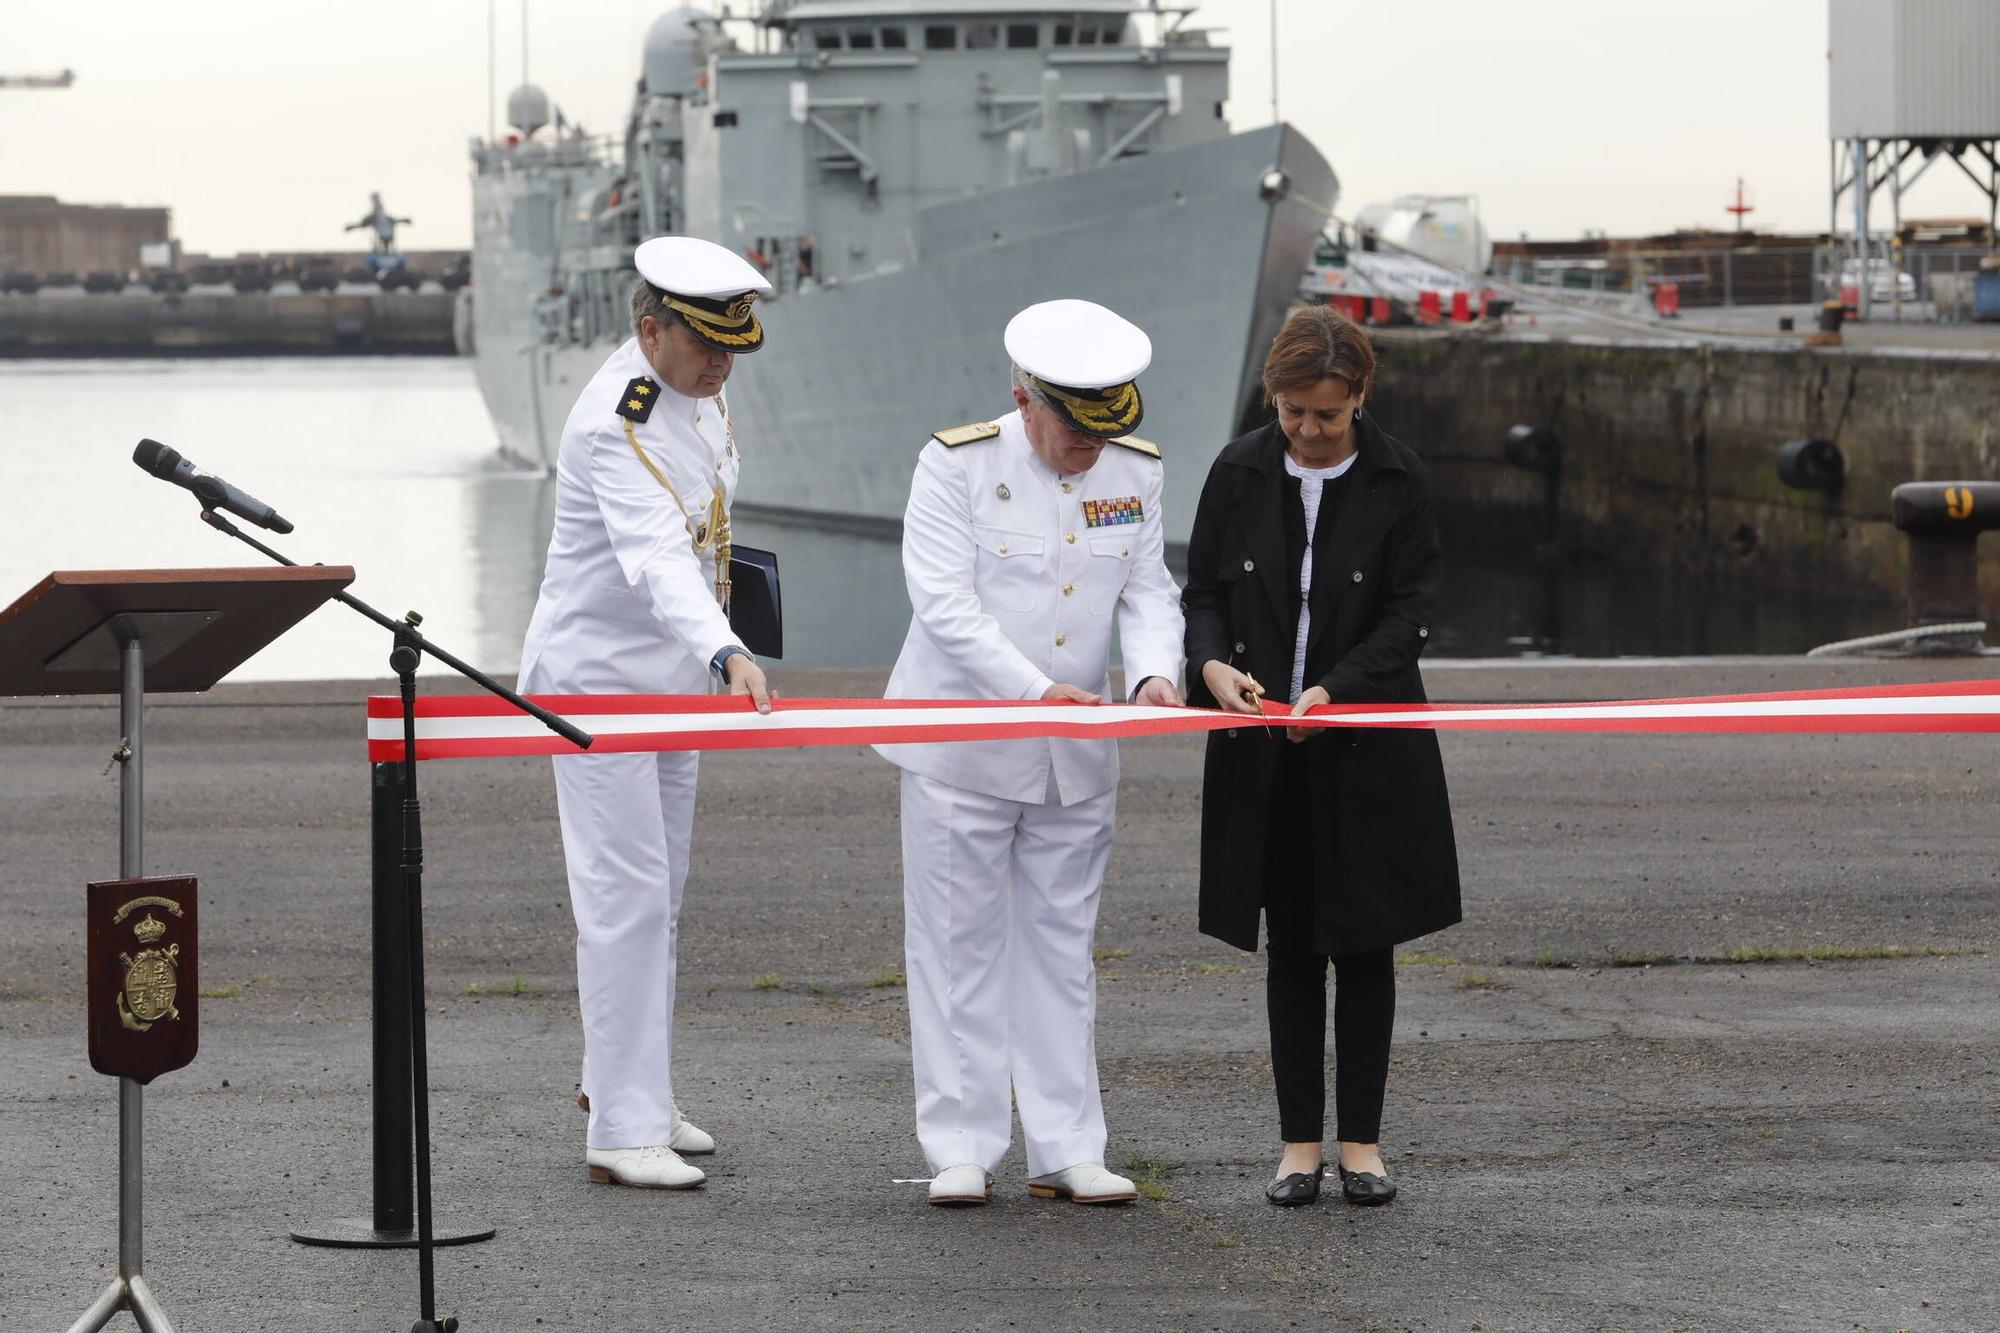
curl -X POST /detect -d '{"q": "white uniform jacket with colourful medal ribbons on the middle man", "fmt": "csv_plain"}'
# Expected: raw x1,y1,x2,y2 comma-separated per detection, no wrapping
878,412,1182,805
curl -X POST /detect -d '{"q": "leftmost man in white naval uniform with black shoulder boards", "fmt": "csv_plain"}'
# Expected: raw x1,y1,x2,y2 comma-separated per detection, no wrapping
520,236,770,1189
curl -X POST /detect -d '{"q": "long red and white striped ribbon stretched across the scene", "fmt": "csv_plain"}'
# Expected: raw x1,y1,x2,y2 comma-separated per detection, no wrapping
368,681,2000,763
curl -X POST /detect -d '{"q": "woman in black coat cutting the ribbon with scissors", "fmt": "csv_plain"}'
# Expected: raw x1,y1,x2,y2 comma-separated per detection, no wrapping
1182,306,1460,1205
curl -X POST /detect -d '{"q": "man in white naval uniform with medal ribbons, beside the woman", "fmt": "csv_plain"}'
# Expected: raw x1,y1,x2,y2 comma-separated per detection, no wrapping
882,300,1182,1203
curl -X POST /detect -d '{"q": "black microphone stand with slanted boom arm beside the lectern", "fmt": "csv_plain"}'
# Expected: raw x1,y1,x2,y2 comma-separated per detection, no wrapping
196,492,592,1333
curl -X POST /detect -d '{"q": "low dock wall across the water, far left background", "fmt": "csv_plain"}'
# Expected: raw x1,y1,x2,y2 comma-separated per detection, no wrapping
0,292,454,356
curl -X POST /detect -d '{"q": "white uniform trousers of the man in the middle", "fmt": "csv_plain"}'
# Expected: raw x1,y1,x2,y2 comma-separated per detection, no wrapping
902,771,1118,1175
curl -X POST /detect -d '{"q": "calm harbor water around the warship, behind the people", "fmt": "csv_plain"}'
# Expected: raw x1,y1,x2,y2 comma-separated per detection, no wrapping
0,356,1900,685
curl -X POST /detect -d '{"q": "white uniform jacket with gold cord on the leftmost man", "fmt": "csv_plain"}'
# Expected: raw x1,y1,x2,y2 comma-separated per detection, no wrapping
520,338,740,695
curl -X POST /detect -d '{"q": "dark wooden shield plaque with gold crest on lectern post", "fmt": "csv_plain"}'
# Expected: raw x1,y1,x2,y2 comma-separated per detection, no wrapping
84,875,202,1083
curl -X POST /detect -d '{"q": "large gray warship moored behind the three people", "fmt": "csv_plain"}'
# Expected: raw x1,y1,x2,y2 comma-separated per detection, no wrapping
456,0,1338,540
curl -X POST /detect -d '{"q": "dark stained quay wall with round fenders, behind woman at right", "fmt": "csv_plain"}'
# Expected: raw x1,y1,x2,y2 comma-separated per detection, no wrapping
1370,332,2000,620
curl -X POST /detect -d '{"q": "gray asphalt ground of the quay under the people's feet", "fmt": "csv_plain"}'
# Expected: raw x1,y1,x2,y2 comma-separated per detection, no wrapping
0,658,2000,1333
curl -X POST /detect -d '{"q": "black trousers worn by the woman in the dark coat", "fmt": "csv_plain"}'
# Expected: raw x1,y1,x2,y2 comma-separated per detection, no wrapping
1264,741,1396,1143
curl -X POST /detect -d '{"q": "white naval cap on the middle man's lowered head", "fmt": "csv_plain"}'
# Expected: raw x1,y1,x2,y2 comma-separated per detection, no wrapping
1006,300,1152,438
